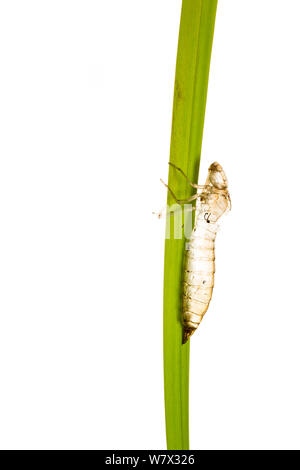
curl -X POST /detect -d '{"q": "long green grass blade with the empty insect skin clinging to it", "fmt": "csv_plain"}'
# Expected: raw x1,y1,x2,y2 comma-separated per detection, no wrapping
164,0,217,450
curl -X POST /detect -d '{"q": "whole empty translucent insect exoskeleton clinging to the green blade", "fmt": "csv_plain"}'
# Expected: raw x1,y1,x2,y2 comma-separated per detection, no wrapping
164,162,231,343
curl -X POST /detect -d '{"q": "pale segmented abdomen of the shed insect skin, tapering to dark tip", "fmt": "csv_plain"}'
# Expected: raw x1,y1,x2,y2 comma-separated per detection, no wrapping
182,222,216,343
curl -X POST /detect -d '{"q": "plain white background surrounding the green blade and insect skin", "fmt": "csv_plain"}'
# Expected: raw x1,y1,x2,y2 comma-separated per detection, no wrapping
0,0,300,449
